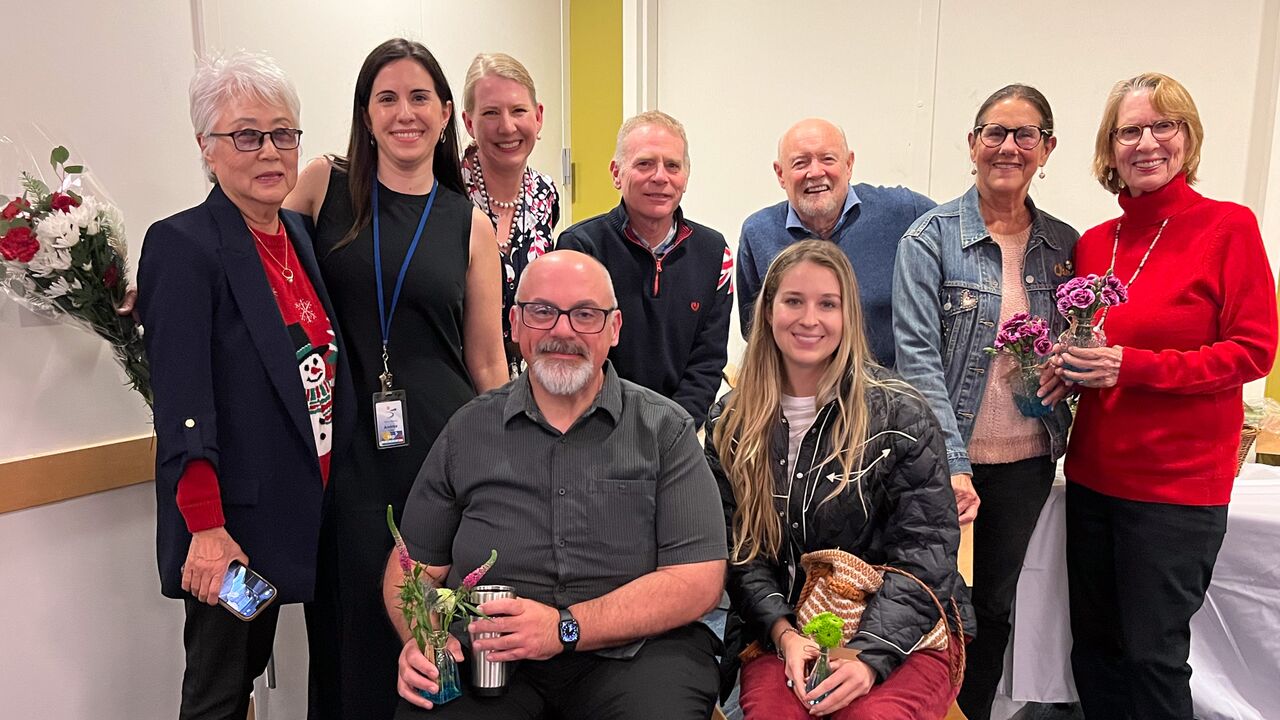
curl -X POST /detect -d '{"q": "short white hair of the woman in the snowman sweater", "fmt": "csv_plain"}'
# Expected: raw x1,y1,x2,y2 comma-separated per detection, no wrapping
188,50,302,182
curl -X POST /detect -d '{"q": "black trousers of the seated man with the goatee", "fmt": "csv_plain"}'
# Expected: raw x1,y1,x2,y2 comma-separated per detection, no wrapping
396,623,719,720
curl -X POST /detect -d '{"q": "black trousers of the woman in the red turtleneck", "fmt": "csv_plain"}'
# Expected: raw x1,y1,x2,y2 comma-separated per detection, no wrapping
1066,483,1226,720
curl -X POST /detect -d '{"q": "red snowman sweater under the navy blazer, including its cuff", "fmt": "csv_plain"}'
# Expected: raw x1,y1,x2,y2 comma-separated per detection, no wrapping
177,223,338,533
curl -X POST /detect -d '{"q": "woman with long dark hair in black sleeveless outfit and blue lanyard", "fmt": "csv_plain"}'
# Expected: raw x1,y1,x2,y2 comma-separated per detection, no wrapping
287,38,507,719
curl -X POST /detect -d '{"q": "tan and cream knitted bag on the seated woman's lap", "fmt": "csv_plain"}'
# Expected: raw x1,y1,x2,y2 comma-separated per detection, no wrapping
741,550,965,687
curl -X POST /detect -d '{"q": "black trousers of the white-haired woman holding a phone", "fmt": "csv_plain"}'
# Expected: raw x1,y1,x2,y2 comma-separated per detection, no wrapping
178,598,280,720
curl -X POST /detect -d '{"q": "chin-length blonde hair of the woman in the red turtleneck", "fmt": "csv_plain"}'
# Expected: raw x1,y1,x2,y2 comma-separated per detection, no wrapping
1093,73,1204,195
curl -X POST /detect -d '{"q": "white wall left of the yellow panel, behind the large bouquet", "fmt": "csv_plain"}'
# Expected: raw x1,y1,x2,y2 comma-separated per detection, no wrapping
0,0,562,720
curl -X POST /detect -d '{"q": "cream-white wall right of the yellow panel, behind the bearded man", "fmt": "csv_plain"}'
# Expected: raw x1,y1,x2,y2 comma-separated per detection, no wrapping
655,0,1280,376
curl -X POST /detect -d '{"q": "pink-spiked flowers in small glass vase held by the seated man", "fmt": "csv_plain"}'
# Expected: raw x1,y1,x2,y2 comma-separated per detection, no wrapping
387,505,498,705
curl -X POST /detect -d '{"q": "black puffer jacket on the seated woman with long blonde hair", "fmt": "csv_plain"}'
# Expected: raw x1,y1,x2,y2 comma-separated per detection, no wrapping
707,366,974,689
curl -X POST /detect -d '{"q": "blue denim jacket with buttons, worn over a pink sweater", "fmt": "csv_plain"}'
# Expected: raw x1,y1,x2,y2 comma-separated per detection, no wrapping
893,186,1080,474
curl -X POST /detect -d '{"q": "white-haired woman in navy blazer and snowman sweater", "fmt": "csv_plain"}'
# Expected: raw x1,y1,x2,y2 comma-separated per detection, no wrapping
138,53,352,719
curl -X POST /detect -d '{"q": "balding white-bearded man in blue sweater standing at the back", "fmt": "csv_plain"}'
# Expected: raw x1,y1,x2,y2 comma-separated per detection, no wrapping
737,118,936,368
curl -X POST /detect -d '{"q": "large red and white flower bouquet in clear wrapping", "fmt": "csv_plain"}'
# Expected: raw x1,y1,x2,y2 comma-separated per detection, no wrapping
0,146,151,405
